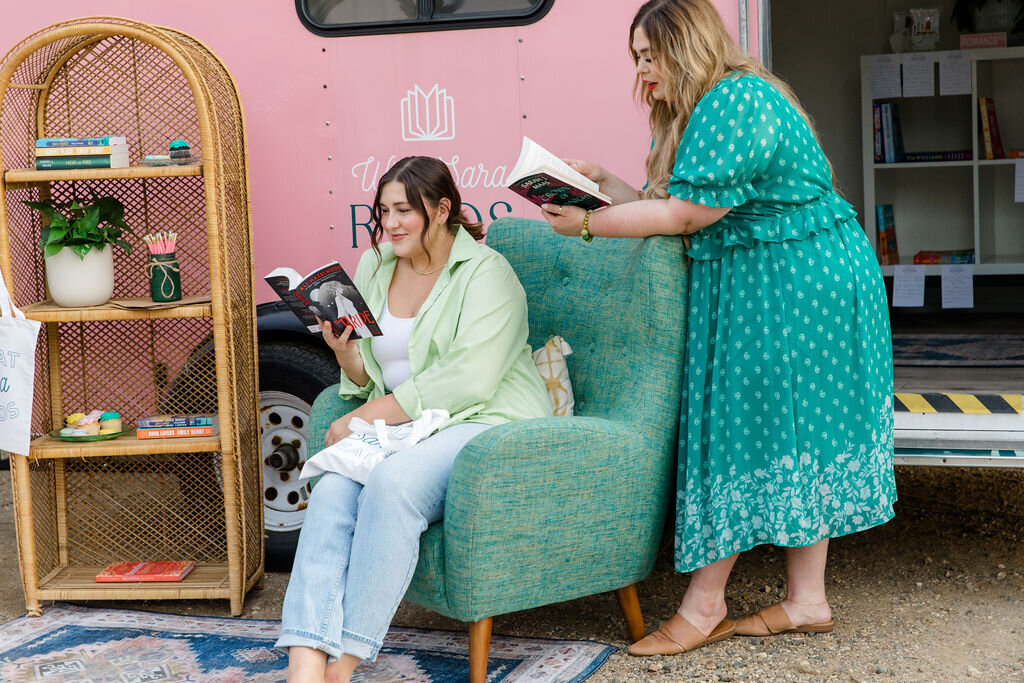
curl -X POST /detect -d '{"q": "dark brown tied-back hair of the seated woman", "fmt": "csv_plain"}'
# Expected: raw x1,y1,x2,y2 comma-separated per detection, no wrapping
370,157,484,265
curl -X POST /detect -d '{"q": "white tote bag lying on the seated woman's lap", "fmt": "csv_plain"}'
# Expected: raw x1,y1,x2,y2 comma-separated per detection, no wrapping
299,410,450,484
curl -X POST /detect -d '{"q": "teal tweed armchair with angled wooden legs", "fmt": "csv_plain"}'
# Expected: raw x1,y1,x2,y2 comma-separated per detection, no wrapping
309,218,687,681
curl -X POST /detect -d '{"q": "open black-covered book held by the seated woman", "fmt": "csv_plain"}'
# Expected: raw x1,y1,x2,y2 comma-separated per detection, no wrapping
263,261,382,339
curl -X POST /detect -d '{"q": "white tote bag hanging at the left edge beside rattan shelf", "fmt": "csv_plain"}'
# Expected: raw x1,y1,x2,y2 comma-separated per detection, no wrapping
0,273,39,456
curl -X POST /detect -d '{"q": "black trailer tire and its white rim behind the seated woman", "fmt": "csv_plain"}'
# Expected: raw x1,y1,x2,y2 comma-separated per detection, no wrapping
259,341,339,571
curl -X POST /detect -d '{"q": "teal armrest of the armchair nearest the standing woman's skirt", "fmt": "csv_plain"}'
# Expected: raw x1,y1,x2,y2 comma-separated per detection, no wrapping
443,417,675,618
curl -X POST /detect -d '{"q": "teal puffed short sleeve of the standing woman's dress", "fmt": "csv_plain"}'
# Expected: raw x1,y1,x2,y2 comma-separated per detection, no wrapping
669,76,781,208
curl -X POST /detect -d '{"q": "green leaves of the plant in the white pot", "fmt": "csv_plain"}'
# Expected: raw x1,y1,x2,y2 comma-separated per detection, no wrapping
22,195,135,259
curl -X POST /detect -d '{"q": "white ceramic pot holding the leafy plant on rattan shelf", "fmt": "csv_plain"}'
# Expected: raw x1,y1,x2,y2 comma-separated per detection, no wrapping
45,245,114,308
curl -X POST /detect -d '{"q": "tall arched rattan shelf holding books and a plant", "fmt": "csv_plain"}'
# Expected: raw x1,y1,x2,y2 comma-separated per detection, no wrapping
0,17,263,614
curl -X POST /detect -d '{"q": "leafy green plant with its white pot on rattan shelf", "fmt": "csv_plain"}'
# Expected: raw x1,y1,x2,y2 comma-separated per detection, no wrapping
23,195,134,307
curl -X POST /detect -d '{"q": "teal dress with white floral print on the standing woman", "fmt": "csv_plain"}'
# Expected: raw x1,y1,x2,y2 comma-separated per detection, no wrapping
669,74,896,571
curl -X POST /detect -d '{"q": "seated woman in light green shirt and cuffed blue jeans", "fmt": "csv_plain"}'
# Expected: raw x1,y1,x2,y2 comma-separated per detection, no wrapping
276,157,551,681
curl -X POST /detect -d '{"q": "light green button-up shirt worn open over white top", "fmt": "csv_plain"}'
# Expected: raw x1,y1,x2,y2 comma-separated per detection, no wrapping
339,228,551,428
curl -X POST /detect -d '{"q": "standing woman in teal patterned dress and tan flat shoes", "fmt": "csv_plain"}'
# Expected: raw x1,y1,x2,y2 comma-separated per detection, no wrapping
542,0,896,655
